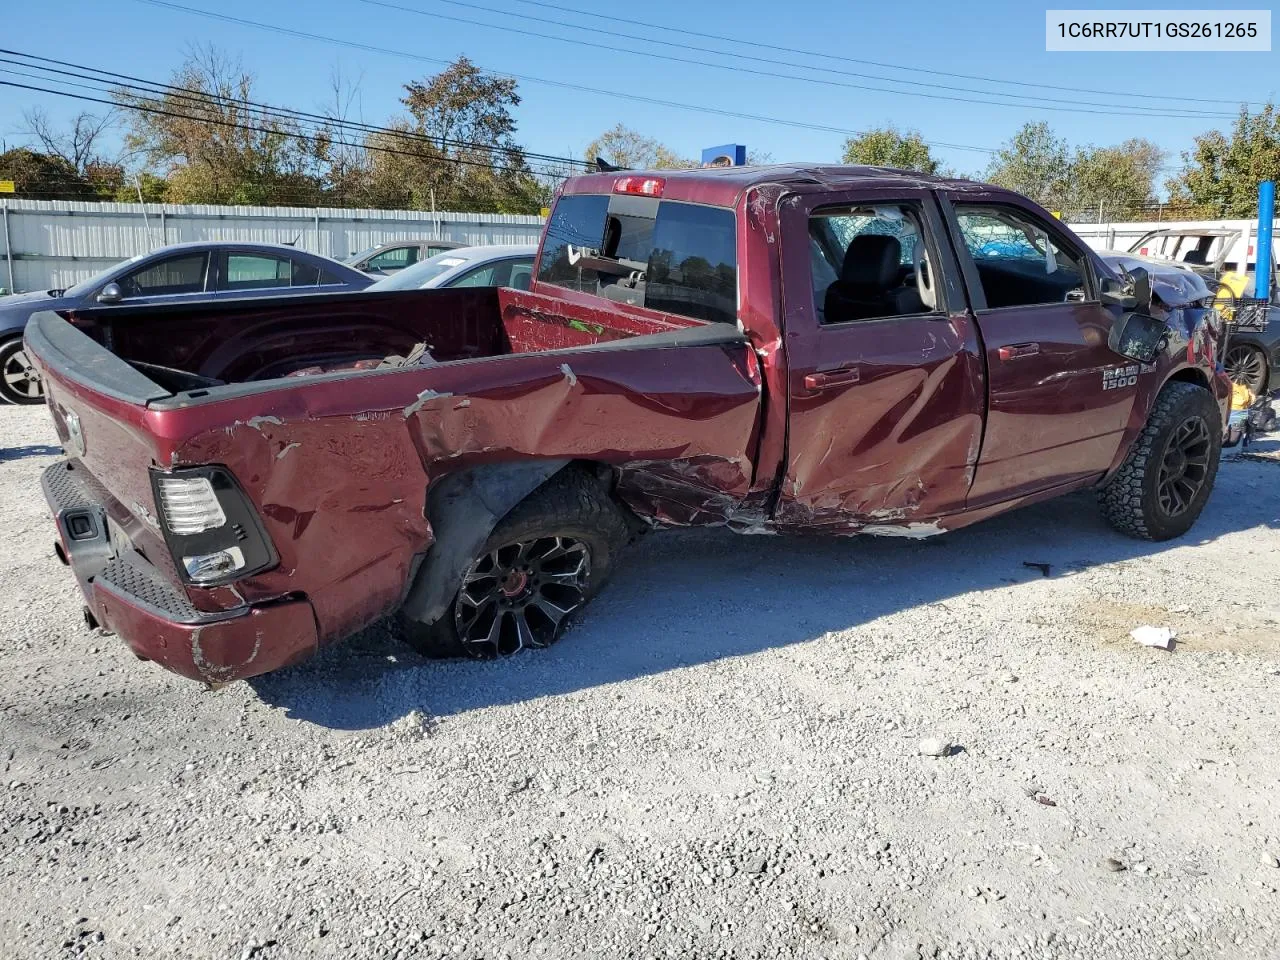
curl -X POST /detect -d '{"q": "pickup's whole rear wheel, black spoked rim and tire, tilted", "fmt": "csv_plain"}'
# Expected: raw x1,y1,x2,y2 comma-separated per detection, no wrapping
399,468,628,659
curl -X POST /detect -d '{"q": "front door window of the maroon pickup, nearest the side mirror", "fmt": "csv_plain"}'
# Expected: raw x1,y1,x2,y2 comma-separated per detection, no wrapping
956,204,1087,310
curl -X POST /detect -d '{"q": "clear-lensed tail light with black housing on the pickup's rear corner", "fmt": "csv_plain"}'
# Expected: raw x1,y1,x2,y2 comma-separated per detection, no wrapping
151,467,279,586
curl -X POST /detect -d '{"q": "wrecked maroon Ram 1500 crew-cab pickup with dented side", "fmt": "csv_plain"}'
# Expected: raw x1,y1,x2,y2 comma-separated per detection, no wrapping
26,166,1229,684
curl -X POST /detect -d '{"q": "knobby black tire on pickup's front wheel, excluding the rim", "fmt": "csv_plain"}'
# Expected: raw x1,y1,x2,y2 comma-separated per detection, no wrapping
1098,381,1222,540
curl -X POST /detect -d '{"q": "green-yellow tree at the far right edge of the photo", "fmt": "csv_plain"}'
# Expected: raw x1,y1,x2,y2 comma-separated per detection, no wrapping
1166,101,1280,218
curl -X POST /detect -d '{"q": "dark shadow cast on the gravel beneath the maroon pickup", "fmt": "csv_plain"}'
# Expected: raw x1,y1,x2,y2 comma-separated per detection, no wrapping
250,462,1280,730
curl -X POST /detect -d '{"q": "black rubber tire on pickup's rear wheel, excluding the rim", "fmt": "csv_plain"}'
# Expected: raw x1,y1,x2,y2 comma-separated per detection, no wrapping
397,467,631,658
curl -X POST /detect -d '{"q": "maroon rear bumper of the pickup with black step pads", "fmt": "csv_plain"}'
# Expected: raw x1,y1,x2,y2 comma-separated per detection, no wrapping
41,461,317,684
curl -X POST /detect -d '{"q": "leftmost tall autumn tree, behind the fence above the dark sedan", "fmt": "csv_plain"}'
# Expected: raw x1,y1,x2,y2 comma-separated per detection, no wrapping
114,47,326,204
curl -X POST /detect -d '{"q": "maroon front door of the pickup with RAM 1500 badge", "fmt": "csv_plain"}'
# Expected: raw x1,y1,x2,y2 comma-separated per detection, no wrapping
943,195,1143,507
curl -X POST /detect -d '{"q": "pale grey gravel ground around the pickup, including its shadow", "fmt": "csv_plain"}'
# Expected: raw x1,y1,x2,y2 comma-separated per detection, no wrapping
0,407,1280,960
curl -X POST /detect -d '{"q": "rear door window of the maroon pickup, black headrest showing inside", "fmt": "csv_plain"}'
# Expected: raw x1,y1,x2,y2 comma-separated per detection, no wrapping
809,204,938,324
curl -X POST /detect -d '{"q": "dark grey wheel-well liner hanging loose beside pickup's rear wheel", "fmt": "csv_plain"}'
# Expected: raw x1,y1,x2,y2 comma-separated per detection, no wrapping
402,460,570,623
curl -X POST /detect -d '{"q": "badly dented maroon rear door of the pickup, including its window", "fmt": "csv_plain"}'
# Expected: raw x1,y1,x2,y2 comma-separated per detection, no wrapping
776,189,984,535
